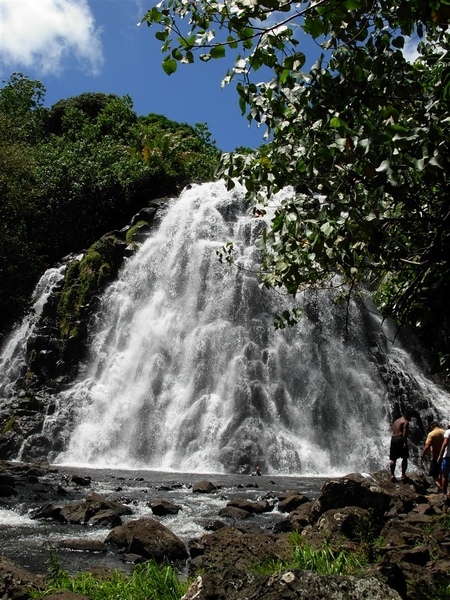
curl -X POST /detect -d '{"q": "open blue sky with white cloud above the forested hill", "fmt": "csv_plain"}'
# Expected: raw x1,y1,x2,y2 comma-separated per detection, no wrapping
0,0,274,151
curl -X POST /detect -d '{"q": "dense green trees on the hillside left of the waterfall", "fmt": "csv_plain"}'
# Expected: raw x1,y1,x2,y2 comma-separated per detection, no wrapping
0,73,220,337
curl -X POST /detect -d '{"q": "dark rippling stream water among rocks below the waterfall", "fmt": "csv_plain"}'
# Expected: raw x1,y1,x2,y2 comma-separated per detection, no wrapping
0,466,324,574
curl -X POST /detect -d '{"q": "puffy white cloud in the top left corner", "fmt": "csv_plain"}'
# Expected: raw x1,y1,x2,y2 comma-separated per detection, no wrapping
0,0,103,74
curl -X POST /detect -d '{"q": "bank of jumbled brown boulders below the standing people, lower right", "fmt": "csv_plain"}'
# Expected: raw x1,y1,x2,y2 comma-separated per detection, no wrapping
185,470,450,600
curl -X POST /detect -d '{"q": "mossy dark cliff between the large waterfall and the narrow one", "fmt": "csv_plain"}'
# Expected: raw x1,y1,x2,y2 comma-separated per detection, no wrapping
0,198,167,460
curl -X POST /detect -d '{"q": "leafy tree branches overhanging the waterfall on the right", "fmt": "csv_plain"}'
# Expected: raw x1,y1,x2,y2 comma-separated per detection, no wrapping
143,0,450,373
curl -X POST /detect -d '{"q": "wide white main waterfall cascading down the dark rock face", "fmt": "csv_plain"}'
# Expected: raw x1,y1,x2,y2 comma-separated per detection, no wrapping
45,182,448,474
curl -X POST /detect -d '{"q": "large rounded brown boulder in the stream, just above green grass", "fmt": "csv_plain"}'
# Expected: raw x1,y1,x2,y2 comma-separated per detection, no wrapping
105,518,188,561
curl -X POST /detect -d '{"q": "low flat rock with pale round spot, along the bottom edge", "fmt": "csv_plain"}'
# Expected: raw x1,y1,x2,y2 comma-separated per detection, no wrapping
179,567,401,600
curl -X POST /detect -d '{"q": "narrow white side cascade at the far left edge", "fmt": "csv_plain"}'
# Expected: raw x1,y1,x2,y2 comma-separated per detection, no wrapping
0,264,67,397
